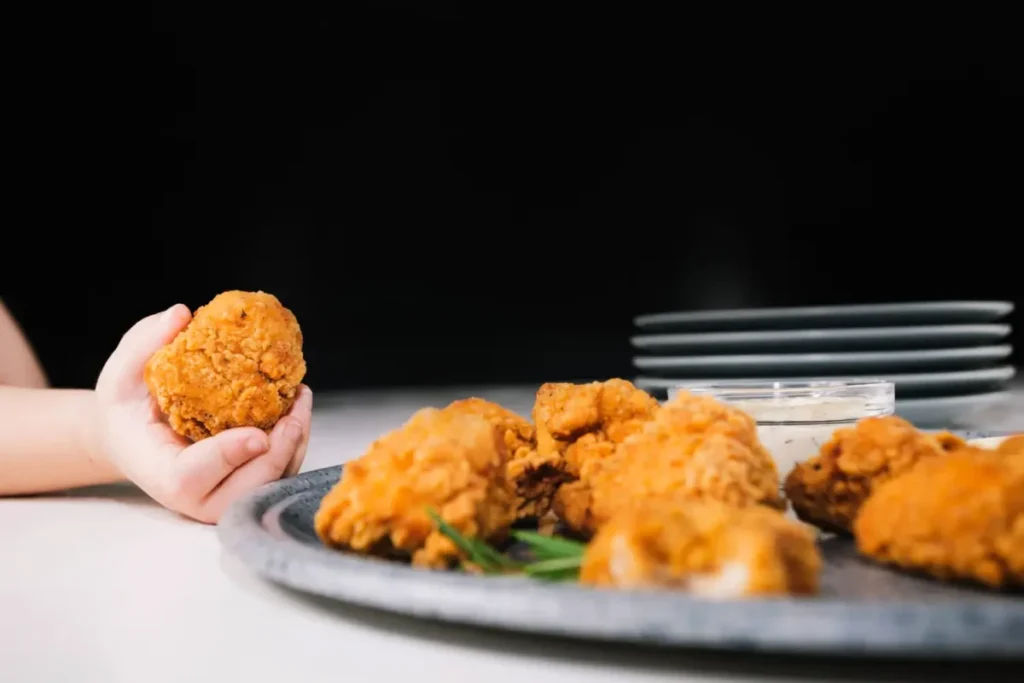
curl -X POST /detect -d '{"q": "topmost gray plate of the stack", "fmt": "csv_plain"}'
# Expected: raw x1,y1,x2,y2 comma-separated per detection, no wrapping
633,301,1014,331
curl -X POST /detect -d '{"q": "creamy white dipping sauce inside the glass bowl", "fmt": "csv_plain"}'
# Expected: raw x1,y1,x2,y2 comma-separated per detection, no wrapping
727,396,880,483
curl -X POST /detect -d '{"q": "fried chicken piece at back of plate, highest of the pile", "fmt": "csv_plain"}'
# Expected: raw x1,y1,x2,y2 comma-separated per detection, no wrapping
534,379,660,476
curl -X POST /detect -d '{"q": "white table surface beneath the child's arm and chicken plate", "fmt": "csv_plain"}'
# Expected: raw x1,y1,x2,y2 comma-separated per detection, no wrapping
0,388,1024,683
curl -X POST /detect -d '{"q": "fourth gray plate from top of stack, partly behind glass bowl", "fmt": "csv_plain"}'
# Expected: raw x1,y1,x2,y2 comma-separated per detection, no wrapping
634,366,1017,396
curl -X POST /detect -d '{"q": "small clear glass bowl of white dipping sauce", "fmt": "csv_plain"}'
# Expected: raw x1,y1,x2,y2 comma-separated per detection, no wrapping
669,379,896,483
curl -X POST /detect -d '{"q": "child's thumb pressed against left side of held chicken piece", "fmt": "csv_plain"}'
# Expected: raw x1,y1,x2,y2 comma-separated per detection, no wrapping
96,303,191,399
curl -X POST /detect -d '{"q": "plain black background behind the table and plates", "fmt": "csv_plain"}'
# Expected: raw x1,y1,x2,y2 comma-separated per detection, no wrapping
3,2,1024,389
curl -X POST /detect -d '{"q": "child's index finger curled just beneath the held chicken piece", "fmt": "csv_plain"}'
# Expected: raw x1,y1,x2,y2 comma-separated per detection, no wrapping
168,427,270,521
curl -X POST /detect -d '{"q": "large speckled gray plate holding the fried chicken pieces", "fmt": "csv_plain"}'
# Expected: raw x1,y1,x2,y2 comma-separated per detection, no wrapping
218,450,1024,658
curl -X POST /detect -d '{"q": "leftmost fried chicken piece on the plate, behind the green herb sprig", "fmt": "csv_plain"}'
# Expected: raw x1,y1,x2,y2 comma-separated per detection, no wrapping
314,408,517,568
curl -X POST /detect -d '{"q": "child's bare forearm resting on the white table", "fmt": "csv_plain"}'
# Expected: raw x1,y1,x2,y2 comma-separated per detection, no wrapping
0,386,123,496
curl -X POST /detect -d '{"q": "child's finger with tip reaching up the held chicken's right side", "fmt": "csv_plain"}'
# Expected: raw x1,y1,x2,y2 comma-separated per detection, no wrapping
203,397,312,521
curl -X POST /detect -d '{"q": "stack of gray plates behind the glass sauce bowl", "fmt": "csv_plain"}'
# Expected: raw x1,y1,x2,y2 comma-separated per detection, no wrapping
632,301,1015,427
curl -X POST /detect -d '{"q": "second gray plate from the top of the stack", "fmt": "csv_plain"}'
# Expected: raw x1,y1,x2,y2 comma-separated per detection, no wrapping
630,325,1011,353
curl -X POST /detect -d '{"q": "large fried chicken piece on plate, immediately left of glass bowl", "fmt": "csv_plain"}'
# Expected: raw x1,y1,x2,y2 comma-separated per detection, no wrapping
555,392,784,533
